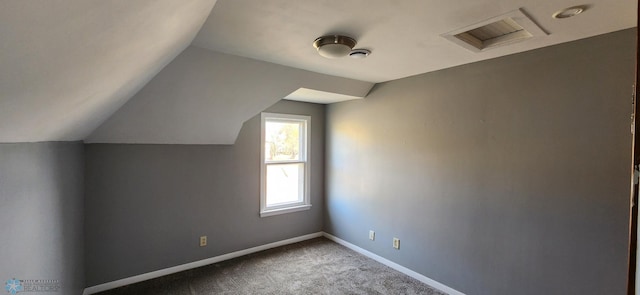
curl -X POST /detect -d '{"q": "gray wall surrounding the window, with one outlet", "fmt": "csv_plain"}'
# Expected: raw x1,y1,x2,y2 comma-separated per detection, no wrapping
86,101,325,286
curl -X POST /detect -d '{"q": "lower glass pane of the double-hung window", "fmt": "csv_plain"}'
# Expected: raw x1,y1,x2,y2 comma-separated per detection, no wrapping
266,163,304,207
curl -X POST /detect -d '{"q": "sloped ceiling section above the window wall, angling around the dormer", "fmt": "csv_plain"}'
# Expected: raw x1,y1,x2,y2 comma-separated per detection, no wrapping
86,46,373,144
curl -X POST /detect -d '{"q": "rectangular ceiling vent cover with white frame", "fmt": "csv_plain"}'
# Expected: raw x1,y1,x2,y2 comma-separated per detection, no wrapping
442,9,547,52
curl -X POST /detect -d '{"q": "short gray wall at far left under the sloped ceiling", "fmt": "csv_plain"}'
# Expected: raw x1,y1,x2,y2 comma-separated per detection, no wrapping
0,142,84,295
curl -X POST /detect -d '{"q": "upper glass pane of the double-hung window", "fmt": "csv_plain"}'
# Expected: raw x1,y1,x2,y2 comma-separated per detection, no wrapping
264,121,302,161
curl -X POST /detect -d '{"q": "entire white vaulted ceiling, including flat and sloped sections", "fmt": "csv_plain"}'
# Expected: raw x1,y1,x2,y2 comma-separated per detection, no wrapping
0,0,637,144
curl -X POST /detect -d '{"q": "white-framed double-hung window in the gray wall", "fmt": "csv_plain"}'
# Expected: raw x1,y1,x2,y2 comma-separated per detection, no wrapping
260,113,311,217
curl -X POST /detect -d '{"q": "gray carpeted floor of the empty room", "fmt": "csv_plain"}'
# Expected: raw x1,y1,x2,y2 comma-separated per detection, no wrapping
99,238,445,295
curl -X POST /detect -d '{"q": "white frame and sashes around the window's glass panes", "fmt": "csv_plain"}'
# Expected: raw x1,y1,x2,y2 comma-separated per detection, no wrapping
260,113,311,217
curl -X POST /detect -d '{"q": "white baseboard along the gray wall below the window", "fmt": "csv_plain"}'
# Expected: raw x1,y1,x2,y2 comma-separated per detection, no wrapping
82,232,323,295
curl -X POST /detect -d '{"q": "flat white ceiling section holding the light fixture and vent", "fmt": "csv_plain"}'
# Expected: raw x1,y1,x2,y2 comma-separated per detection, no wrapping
193,0,637,82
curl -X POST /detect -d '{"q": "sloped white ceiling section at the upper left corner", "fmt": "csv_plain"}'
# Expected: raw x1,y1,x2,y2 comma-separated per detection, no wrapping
0,0,216,142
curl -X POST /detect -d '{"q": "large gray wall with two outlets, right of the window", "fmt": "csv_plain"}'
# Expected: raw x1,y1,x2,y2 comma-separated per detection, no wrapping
325,30,635,295
